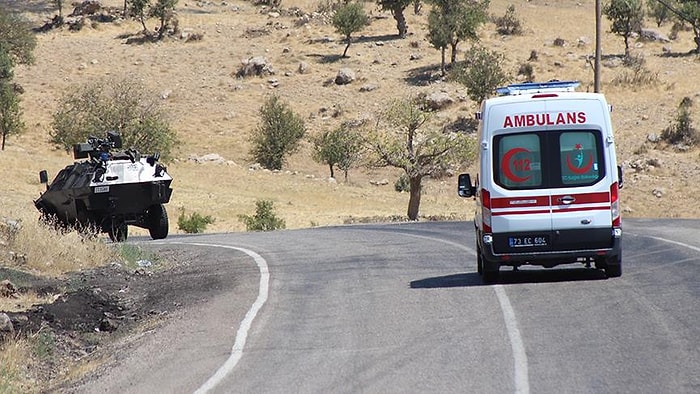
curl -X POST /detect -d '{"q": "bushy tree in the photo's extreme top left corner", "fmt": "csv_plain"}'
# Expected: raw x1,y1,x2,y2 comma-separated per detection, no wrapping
0,7,36,65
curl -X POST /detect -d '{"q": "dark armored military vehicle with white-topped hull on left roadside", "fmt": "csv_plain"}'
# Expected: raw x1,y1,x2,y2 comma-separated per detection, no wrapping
34,132,173,242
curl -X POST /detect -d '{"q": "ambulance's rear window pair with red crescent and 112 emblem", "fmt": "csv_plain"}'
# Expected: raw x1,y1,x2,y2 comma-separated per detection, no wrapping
493,130,605,190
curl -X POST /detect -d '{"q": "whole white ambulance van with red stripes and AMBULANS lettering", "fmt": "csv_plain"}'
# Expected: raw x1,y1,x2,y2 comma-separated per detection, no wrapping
458,81,622,282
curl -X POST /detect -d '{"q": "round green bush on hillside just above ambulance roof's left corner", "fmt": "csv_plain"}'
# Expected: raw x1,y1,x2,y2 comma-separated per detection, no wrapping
452,46,510,103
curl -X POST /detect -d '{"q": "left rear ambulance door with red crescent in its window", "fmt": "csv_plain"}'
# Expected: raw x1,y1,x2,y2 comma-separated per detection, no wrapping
482,96,552,255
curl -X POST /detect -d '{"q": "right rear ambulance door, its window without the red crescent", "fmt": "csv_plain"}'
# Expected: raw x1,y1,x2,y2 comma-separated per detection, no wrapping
546,96,617,251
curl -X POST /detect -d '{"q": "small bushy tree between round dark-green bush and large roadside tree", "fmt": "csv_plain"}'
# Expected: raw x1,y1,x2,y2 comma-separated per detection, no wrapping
313,123,363,181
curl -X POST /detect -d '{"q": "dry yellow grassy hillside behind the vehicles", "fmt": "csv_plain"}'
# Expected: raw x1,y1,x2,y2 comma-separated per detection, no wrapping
0,0,700,232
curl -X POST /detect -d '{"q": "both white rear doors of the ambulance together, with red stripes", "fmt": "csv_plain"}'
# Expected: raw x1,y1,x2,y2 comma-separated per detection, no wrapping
484,94,612,255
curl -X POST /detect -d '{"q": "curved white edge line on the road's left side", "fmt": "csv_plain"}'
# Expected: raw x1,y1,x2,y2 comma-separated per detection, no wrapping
161,242,270,394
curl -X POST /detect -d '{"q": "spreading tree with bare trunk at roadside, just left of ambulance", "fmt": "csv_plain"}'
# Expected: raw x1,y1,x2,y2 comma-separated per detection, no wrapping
366,99,476,220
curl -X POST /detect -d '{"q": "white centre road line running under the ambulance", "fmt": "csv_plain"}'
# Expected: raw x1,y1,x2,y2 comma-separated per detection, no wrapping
396,233,530,394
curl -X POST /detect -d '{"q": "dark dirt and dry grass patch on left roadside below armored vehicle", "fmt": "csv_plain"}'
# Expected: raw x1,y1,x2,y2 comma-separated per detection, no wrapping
0,247,220,389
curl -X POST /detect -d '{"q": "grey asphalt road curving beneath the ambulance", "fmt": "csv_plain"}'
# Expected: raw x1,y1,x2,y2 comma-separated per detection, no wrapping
79,220,700,393
